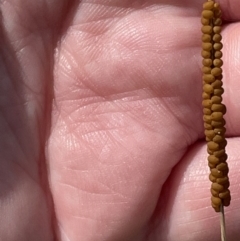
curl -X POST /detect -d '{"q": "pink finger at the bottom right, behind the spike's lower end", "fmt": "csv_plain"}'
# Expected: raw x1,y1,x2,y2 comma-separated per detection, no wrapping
153,138,240,241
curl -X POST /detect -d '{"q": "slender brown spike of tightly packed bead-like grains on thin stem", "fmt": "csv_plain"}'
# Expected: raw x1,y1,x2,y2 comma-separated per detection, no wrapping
201,0,231,212
